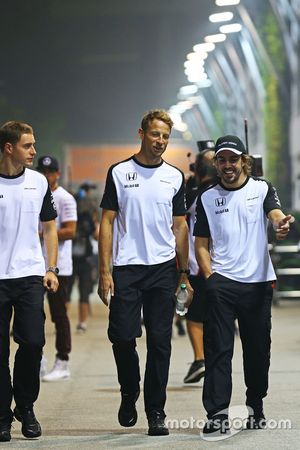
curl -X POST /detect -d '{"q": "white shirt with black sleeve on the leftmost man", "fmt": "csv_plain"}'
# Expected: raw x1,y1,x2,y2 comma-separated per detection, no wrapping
0,168,56,280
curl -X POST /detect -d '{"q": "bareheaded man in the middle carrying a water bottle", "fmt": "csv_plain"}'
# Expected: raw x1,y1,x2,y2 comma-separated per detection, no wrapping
98,110,193,436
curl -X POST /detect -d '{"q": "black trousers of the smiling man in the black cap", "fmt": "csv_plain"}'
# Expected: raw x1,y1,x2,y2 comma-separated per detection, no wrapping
203,273,273,418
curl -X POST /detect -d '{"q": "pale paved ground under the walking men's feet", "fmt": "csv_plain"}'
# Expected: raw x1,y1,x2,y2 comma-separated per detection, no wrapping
4,292,300,450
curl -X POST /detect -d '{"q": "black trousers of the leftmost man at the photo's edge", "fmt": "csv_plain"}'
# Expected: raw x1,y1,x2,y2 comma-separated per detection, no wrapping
0,276,45,421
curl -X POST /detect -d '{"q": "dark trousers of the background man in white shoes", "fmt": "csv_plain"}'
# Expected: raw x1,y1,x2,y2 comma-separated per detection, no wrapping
47,276,71,361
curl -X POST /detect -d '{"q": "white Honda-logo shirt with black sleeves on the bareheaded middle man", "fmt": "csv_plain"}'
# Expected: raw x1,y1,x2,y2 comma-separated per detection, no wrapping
100,156,186,266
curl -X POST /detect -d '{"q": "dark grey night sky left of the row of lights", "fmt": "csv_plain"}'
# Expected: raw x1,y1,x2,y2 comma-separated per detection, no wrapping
0,0,216,143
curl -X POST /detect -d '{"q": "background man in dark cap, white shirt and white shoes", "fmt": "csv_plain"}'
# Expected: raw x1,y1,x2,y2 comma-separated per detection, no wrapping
37,156,77,381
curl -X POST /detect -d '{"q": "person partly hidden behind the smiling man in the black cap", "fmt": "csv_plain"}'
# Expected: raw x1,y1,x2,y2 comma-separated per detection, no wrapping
183,146,218,383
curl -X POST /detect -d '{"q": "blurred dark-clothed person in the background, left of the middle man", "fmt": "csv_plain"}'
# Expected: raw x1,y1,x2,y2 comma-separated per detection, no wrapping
72,182,99,334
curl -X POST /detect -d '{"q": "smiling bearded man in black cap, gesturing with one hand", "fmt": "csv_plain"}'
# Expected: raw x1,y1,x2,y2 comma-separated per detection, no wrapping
194,135,293,435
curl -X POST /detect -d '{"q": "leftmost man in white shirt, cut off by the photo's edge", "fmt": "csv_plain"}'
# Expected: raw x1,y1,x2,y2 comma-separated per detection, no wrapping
0,121,58,442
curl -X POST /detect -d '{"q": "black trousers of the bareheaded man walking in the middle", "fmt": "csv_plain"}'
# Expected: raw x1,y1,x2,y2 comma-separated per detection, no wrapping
108,259,177,414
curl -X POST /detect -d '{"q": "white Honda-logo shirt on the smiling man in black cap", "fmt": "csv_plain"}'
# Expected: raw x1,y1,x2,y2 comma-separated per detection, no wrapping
194,177,281,283
